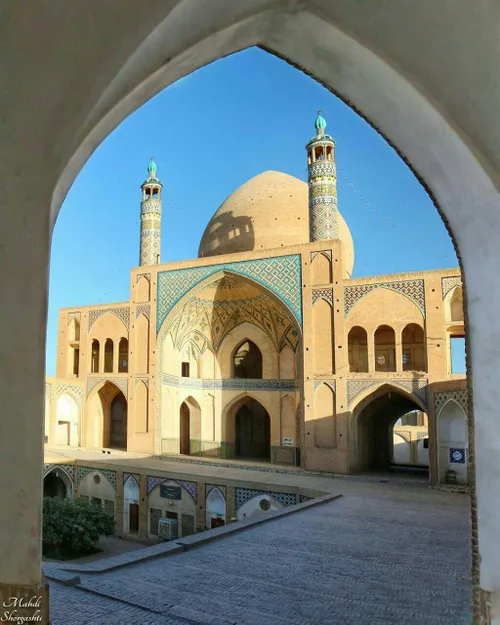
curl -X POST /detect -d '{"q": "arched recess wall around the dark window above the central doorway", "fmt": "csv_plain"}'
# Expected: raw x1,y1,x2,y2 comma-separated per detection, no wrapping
216,321,279,379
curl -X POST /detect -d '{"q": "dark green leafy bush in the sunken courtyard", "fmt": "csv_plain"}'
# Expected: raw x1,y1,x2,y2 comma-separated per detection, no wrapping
42,497,115,560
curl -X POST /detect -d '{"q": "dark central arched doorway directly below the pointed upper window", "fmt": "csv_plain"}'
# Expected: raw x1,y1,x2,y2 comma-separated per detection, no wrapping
235,397,271,461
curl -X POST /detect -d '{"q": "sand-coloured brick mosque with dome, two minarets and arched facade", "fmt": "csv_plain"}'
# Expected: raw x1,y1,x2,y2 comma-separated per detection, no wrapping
45,114,468,484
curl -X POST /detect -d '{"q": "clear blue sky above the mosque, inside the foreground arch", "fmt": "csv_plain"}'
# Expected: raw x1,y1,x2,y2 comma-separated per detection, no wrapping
47,48,463,375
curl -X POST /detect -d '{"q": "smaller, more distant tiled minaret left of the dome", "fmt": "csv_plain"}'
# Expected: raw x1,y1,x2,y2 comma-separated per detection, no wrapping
139,158,163,267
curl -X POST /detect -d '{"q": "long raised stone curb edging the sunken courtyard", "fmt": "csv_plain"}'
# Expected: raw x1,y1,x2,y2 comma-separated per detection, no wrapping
44,494,342,586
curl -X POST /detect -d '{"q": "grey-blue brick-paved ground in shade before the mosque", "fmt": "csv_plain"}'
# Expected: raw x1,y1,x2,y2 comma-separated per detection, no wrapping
47,480,472,625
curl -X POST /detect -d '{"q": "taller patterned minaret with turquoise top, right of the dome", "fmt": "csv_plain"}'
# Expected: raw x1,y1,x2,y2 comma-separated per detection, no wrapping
306,111,339,241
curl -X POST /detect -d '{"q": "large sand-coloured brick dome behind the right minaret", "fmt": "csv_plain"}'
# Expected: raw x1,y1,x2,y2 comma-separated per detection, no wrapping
198,171,354,277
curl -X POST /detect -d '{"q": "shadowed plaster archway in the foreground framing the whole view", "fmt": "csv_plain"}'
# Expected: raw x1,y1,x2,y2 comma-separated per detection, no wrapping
0,0,500,622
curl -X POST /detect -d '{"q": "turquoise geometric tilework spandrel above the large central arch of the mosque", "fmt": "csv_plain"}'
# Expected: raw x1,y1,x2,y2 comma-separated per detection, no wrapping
157,254,302,332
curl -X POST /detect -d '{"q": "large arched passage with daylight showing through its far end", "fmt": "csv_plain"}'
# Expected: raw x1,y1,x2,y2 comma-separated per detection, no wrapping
355,387,428,478
